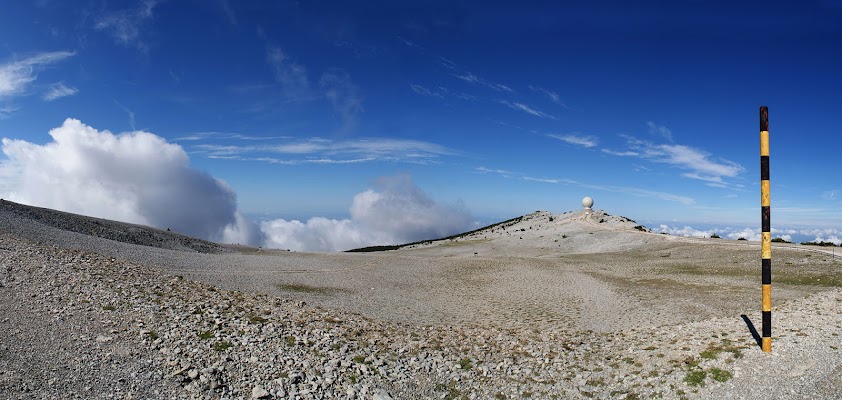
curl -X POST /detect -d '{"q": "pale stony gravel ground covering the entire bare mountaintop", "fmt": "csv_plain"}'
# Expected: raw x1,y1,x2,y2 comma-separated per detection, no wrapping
0,202,842,399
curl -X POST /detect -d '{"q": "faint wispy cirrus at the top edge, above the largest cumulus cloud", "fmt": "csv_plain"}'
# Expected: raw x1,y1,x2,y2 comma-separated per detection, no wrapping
94,0,160,53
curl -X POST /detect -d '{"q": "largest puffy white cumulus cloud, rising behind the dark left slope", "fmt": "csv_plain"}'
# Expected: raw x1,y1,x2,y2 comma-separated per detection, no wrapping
0,119,262,244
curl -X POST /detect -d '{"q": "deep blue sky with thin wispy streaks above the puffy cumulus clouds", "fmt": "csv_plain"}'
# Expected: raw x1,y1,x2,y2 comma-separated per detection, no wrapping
0,0,842,250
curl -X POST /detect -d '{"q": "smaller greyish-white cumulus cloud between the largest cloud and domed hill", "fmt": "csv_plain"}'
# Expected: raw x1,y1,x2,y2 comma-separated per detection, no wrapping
261,176,474,251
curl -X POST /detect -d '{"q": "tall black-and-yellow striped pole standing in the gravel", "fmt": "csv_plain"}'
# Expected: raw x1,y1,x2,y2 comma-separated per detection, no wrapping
760,106,772,353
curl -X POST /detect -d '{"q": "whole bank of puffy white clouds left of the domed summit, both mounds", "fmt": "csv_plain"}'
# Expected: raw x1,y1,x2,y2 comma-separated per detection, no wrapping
0,118,475,251
